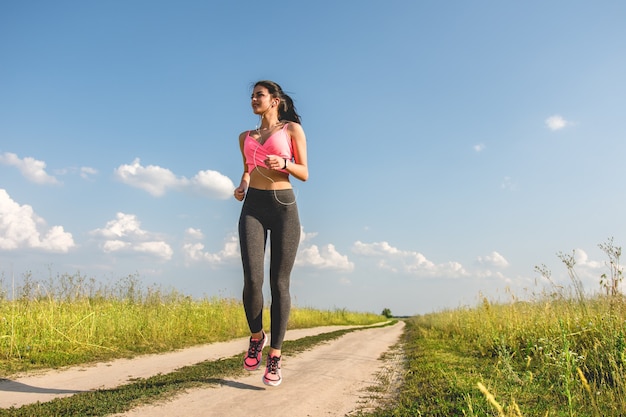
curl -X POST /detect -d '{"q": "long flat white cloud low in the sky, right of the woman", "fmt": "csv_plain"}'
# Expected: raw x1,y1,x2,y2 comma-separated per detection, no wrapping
352,241,468,278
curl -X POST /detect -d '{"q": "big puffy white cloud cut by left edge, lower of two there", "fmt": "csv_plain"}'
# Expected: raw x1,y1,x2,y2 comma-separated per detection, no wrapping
0,189,75,253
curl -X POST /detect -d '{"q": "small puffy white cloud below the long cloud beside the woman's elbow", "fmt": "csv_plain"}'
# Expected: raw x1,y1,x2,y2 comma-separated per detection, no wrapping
90,213,174,261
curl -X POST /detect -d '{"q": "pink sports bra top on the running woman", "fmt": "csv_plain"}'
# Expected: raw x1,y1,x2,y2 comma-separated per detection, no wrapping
243,123,293,174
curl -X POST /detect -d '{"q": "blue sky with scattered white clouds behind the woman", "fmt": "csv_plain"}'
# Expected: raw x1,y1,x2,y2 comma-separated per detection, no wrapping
0,0,626,314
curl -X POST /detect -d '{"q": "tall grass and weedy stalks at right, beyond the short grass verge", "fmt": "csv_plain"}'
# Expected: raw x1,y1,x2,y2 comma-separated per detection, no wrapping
458,239,626,417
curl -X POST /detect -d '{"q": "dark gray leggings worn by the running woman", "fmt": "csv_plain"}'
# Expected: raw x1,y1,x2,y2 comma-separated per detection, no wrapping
239,188,300,349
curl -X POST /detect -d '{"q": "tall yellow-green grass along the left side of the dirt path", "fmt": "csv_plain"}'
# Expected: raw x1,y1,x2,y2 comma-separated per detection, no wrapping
0,274,384,376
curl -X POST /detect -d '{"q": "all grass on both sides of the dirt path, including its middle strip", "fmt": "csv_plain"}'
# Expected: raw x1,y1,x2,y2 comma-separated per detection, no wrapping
0,237,626,417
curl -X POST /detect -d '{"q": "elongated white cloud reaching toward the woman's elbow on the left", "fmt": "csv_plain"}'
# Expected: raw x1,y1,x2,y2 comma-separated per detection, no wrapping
115,158,235,199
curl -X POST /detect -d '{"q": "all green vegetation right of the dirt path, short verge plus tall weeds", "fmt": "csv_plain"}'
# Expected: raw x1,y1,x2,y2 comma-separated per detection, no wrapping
360,239,626,417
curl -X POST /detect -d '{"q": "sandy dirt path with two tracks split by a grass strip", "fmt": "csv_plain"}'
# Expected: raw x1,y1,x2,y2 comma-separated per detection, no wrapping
0,322,404,417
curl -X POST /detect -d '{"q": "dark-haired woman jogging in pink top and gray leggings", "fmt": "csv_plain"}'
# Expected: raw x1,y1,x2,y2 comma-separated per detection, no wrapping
234,81,309,386
